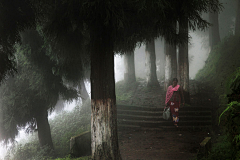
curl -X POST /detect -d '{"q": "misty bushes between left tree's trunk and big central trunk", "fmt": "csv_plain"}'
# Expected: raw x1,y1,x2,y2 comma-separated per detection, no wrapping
49,100,91,157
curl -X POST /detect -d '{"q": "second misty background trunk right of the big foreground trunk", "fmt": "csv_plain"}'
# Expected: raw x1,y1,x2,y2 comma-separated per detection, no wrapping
145,39,159,86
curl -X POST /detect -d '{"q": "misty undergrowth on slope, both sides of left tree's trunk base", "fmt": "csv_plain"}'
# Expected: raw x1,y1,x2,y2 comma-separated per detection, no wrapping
9,100,91,160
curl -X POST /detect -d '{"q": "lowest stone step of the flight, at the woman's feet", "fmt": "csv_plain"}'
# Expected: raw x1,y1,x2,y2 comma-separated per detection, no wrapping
118,119,211,128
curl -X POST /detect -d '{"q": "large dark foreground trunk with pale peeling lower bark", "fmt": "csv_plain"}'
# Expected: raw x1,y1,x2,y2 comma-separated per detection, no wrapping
91,25,121,160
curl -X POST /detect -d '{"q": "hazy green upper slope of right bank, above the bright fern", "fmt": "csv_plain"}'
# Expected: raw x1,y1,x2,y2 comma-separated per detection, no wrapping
195,36,240,100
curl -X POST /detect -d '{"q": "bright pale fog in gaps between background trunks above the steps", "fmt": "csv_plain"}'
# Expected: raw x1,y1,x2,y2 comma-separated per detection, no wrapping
115,32,209,82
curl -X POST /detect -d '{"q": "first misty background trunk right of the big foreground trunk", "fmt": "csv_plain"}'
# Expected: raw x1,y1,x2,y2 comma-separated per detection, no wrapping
124,52,136,83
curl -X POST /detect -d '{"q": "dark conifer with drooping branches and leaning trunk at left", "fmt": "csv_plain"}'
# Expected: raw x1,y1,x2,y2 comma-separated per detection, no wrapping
0,31,78,149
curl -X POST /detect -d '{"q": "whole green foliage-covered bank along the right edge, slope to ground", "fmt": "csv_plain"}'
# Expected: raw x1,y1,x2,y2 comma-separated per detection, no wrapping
197,43,240,160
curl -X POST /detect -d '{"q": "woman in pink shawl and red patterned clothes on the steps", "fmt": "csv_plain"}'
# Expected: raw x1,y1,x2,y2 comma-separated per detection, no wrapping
164,78,185,127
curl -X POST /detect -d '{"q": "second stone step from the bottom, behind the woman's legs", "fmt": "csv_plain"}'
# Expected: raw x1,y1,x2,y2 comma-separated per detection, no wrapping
117,114,211,121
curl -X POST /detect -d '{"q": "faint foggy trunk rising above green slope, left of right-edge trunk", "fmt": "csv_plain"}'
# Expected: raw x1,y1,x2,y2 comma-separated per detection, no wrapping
209,12,221,49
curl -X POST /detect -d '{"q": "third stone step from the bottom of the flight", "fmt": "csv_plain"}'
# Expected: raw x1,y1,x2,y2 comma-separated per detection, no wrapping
117,109,212,116
